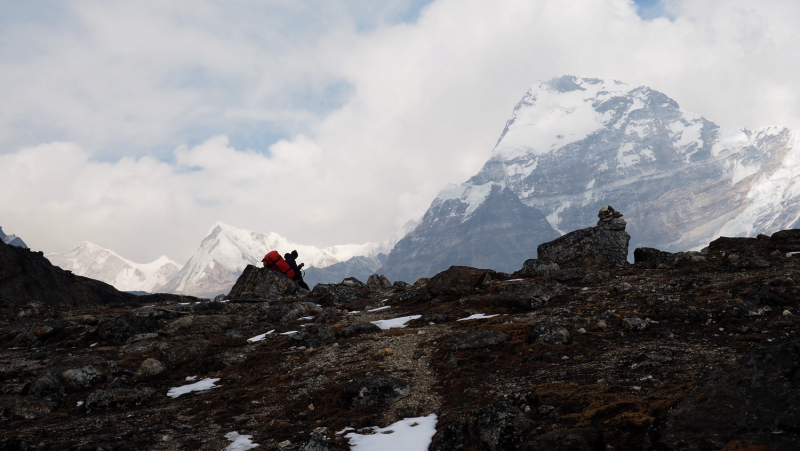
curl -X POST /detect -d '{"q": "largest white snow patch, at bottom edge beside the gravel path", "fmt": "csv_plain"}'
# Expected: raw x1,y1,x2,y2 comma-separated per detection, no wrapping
342,413,437,451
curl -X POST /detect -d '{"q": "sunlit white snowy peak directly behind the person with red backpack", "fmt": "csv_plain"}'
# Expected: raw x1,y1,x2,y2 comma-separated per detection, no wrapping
159,222,402,297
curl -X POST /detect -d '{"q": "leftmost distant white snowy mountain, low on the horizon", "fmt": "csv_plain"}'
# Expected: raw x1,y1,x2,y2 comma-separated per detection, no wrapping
45,241,181,293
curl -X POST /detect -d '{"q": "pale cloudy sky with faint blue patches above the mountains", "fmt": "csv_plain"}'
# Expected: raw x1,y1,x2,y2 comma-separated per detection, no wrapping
0,0,800,263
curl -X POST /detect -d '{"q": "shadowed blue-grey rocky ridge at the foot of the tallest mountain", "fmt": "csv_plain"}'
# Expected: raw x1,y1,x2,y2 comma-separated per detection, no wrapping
378,183,559,282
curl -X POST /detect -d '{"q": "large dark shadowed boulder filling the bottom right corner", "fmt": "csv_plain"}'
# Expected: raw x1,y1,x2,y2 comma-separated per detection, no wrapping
649,341,800,451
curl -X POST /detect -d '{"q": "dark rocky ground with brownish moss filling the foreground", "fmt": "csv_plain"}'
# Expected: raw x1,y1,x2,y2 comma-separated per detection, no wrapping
0,215,800,451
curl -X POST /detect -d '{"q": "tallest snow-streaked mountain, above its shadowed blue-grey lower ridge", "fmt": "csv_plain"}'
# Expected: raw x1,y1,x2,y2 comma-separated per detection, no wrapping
380,76,800,282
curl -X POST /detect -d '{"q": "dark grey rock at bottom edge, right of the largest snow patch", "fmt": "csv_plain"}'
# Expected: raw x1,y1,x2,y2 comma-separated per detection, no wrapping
467,403,534,451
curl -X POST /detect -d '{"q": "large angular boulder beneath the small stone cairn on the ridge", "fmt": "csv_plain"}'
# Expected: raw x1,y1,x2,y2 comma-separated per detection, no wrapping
537,218,631,269
